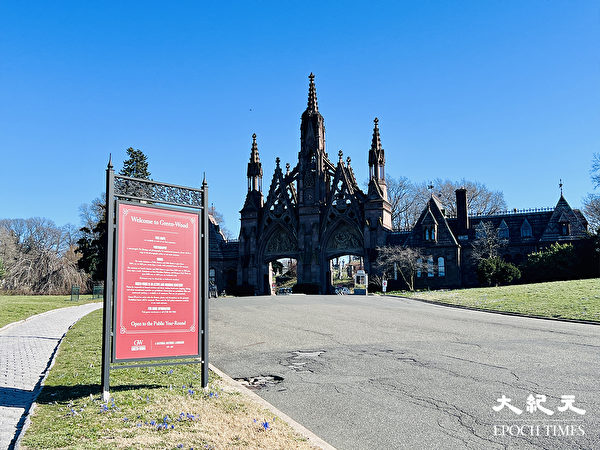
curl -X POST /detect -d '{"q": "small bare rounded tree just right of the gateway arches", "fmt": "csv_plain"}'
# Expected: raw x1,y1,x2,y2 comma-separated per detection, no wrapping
375,246,427,291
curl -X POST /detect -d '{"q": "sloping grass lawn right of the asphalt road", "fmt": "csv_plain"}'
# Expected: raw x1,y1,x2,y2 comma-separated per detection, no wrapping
391,278,600,322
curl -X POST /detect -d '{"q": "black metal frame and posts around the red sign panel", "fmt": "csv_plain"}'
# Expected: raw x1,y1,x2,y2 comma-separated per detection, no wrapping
101,161,209,401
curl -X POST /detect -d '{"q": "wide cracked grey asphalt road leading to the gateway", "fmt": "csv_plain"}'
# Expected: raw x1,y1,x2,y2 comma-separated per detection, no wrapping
210,296,600,449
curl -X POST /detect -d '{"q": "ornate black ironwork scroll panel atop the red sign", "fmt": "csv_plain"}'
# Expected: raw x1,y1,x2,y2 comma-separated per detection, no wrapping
114,175,203,209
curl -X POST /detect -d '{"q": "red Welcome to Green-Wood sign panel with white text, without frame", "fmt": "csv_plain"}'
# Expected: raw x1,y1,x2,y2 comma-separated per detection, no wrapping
114,203,199,360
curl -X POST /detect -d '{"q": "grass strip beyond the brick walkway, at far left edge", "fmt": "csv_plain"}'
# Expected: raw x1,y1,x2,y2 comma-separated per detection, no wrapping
0,295,102,328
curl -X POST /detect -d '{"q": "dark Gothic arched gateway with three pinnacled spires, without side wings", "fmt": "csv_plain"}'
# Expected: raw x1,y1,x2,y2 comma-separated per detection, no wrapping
237,73,392,294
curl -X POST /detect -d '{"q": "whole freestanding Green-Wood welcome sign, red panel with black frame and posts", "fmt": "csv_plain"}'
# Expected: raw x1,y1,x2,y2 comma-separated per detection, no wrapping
102,158,208,401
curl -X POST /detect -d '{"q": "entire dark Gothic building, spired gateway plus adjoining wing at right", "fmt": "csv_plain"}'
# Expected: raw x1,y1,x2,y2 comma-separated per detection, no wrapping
209,74,587,294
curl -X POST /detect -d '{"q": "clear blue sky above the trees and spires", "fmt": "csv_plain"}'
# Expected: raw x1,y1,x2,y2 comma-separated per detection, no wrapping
0,0,600,234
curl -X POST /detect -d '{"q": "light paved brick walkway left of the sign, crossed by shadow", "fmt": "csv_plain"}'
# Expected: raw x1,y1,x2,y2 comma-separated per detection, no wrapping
0,303,102,449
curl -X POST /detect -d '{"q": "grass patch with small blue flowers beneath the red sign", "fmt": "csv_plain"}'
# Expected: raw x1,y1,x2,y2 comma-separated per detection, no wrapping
21,311,313,449
